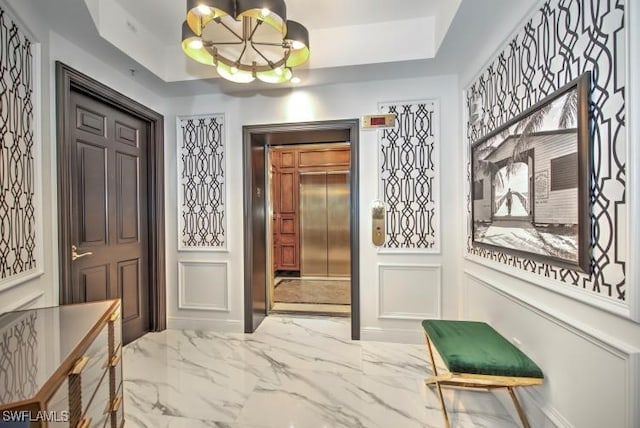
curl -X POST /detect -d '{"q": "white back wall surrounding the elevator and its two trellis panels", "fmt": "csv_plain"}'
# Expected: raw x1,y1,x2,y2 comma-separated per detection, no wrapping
166,76,462,342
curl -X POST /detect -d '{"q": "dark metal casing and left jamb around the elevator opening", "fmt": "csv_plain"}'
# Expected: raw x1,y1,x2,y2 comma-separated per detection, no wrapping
243,119,360,340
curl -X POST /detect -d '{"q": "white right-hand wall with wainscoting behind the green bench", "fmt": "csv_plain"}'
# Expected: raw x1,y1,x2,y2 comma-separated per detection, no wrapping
456,1,640,428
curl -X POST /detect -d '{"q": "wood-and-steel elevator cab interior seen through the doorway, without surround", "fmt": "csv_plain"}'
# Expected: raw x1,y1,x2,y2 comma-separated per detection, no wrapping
267,142,351,316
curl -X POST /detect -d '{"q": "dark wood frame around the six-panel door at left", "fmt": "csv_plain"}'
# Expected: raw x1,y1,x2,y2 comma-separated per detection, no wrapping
56,61,167,331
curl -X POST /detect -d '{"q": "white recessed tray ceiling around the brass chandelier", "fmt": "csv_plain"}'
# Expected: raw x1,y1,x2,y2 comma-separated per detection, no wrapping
32,0,537,96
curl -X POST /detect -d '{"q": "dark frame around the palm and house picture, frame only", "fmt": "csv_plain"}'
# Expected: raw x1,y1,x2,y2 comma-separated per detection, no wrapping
470,72,592,273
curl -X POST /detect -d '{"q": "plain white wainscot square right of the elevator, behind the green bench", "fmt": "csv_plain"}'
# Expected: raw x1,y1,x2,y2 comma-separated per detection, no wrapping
378,264,442,320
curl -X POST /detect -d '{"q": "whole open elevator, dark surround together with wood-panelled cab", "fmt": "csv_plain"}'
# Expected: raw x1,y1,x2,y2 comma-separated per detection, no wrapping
243,119,360,340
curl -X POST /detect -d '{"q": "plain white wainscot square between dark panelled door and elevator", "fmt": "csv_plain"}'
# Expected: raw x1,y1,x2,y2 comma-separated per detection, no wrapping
178,260,230,312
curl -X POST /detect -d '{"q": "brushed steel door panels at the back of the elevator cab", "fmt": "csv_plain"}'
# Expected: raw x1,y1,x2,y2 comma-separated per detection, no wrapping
300,171,351,277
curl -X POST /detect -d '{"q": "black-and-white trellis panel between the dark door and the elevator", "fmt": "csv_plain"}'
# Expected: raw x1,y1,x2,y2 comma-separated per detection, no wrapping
178,114,226,250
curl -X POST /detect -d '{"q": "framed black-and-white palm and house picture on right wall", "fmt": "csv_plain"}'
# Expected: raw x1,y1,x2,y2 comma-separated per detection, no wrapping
471,73,591,273
